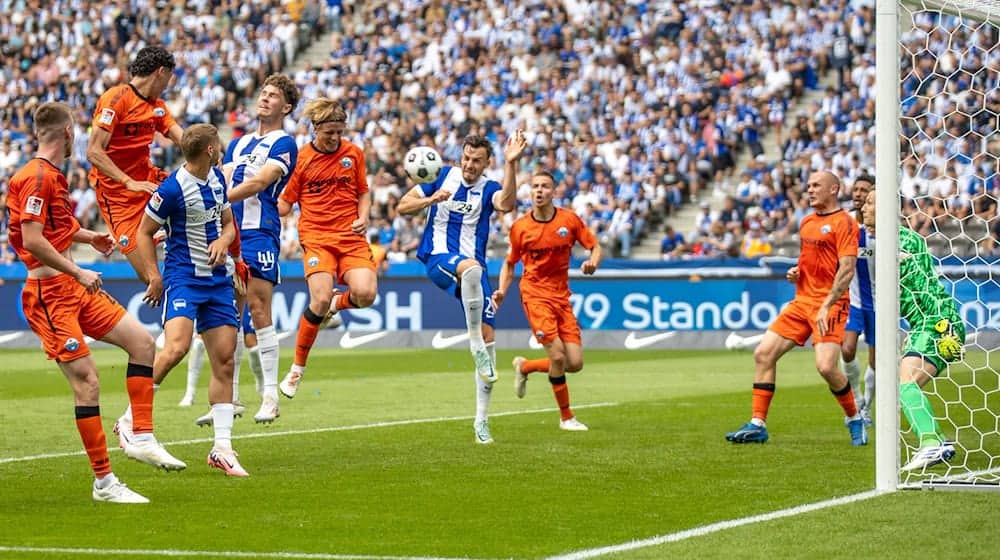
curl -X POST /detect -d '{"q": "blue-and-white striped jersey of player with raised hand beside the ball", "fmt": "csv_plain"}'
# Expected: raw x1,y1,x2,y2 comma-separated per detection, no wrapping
417,165,502,264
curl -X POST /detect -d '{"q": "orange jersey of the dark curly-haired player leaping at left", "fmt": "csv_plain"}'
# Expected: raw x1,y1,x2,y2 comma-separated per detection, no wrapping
90,84,177,200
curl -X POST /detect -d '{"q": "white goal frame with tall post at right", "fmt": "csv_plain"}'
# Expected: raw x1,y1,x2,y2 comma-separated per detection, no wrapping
875,0,1000,492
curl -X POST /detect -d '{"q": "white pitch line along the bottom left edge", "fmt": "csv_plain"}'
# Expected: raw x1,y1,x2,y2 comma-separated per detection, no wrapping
0,546,494,560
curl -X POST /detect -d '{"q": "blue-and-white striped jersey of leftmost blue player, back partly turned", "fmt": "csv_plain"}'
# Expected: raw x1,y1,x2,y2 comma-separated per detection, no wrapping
146,167,234,286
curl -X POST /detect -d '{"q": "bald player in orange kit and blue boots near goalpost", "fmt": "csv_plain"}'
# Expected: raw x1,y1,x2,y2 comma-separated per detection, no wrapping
726,171,868,445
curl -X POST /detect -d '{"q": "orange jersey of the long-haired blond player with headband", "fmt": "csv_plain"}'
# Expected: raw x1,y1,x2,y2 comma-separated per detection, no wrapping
281,139,368,245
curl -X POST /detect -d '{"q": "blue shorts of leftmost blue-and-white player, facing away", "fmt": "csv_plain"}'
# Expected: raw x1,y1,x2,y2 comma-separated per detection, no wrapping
162,279,239,333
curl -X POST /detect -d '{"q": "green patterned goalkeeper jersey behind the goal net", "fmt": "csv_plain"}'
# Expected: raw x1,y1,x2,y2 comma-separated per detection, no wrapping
899,226,961,329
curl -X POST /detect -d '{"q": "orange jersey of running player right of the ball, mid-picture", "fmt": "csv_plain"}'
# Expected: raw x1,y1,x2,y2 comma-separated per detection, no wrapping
507,208,597,301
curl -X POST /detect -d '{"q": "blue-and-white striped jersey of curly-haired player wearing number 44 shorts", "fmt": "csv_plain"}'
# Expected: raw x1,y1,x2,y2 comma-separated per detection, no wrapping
228,130,299,242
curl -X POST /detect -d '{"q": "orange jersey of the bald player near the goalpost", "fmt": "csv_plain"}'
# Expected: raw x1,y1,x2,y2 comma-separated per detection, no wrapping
795,210,858,302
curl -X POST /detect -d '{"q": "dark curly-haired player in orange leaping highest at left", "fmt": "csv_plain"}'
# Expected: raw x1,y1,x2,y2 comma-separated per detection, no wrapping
87,46,184,273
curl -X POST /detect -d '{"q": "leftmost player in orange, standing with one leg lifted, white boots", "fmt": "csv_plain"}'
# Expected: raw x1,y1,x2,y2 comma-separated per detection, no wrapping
7,102,185,503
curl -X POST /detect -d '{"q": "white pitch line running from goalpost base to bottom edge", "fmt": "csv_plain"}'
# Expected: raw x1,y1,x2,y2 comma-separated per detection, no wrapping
546,490,882,560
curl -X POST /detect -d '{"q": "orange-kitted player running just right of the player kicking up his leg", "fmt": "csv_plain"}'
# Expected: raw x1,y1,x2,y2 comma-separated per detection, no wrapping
493,171,602,431
